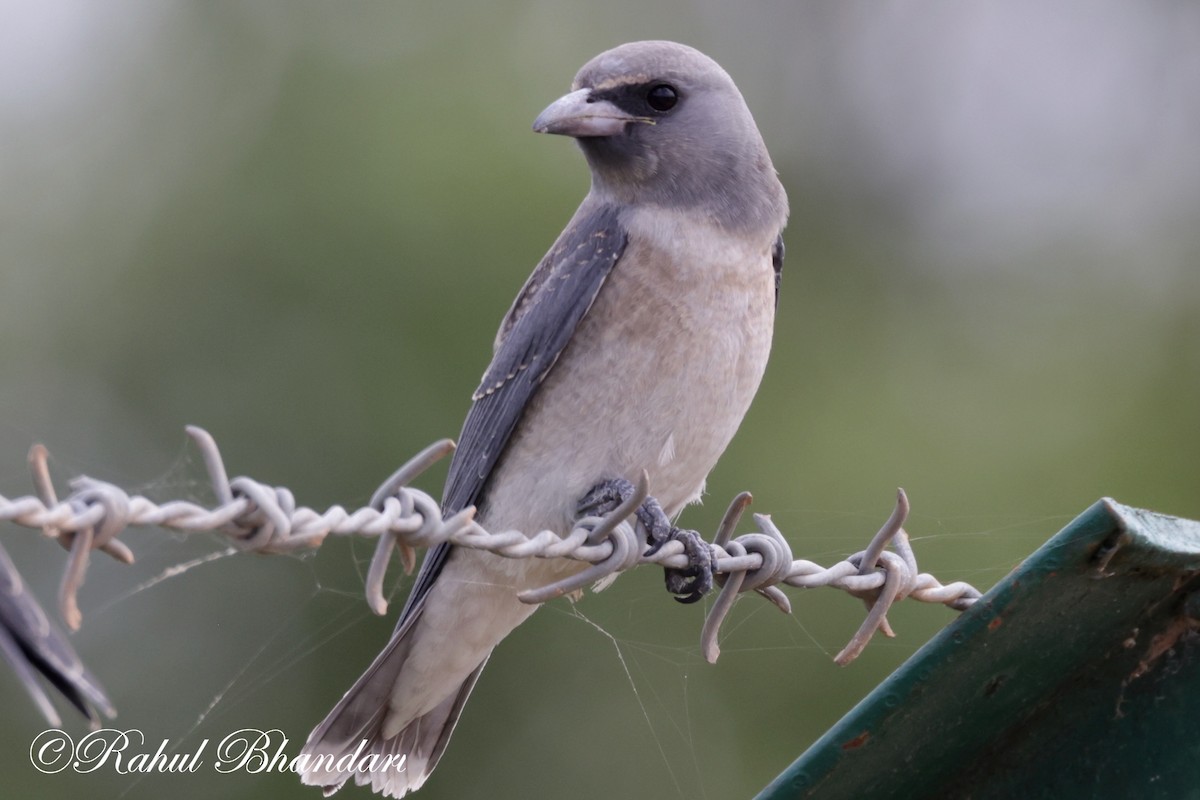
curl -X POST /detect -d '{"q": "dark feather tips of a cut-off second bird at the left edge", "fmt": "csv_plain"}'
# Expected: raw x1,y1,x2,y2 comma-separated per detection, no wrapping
0,547,115,726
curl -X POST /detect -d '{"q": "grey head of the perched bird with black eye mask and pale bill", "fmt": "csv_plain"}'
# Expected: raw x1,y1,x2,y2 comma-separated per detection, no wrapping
533,42,787,235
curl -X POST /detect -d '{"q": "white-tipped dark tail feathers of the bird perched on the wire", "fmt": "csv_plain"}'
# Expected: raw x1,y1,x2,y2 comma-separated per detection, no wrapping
296,634,487,798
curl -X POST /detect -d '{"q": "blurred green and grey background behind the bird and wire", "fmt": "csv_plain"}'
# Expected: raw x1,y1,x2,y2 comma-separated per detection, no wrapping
0,0,1200,800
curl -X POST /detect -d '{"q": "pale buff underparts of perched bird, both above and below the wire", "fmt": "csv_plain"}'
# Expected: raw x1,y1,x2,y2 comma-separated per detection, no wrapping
389,220,775,722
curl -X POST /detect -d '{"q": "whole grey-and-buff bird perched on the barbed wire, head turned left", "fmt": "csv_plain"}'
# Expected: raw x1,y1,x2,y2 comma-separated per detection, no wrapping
298,41,788,798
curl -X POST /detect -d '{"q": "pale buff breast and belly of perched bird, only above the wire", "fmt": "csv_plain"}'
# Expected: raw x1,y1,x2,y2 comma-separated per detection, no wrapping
485,220,775,531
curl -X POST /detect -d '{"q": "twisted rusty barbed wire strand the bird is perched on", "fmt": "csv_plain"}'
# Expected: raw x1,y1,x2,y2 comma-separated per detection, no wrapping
0,426,979,664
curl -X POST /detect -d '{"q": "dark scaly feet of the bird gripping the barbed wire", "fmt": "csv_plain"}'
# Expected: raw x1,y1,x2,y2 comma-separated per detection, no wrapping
577,477,713,603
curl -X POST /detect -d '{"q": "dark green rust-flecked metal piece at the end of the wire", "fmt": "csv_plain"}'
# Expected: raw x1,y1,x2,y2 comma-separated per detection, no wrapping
758,499,1200,800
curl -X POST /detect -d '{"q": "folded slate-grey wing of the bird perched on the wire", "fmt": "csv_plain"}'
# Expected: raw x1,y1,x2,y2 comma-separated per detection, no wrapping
396,204,628,630
